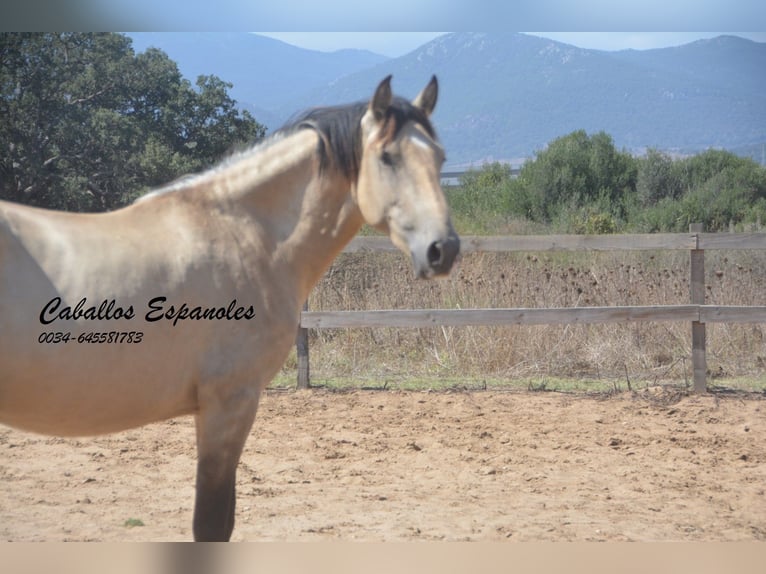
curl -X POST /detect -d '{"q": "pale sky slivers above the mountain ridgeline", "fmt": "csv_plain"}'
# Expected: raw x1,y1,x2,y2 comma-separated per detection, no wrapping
258,32,766,57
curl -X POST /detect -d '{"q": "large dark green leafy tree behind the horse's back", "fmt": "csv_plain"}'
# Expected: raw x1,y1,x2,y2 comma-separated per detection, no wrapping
0,33,265,211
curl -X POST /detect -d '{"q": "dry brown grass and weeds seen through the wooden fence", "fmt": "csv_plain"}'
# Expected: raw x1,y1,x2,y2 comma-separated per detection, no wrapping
283,252,766,394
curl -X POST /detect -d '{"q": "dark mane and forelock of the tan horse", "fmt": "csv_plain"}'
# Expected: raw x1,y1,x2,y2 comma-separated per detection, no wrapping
278,97,436,181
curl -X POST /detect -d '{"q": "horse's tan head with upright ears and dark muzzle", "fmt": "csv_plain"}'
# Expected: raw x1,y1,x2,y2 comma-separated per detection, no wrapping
355,76,460,278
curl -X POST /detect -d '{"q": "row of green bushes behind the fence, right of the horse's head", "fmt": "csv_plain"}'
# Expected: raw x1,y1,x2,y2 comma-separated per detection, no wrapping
450,130,766,234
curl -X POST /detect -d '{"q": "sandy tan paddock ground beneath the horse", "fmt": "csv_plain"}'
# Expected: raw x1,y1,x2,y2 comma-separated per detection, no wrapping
0,390,766,541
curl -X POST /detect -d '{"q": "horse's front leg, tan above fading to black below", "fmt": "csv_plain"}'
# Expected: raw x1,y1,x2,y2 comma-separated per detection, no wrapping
194,392,257,542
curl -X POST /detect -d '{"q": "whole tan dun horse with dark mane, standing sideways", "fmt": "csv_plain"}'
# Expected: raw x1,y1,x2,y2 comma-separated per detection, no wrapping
0,76,460,540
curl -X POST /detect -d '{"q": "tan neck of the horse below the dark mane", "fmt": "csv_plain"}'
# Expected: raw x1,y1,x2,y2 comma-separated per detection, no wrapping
212,129,363,301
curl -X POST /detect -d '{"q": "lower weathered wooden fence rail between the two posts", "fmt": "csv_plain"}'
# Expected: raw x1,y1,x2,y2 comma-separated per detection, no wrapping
301,305,699,329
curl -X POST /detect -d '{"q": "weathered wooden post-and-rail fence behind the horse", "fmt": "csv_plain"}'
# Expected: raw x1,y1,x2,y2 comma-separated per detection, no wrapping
296,224,766,393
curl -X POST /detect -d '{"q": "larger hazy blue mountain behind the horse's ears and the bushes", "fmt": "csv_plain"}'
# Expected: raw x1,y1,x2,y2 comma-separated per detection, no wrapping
302,33,766,163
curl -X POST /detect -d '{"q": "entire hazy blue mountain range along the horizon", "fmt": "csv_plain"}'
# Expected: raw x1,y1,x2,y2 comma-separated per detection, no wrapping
129,32,766,166
